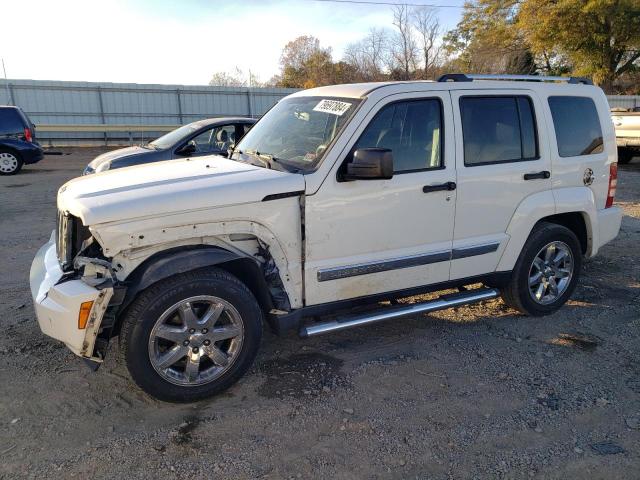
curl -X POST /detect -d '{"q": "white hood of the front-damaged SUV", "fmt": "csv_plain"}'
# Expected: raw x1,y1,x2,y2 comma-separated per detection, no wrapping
58,155,305,226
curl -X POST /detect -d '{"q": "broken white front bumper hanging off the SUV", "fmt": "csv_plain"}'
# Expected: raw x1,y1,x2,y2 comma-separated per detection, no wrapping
29,232,113,361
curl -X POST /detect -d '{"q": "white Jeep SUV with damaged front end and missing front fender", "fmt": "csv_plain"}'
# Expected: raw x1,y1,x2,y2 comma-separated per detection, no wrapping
31,74,622,401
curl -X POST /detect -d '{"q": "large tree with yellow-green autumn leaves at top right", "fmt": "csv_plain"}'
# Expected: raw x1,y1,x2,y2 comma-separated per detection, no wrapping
445,0,640,91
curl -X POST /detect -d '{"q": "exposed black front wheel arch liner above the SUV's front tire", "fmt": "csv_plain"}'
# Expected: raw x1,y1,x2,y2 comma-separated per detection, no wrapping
111,245,274,337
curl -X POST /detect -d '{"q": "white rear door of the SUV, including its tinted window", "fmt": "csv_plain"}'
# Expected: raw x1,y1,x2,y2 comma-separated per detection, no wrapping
451,90,553,279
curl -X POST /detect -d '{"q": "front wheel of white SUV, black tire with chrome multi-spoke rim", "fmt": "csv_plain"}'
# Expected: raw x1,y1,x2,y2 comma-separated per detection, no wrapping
120,268,262,402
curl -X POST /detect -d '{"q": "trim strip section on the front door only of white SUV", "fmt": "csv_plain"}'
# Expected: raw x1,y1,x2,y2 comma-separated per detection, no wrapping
318,250,451,282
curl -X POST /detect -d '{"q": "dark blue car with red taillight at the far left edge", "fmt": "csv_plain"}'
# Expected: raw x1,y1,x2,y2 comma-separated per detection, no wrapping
0,106,44,175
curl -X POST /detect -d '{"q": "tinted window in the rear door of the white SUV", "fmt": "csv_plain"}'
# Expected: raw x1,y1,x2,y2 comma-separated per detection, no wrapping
460,97,538,165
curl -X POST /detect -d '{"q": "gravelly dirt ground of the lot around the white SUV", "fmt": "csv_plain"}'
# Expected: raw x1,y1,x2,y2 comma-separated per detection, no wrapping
0,149,640,479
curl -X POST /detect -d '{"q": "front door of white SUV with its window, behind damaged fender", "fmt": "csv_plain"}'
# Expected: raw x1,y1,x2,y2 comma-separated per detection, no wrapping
305,92,456,305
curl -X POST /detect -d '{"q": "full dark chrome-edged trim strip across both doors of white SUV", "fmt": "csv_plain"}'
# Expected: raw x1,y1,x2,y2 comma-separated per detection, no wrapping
317,242,500,282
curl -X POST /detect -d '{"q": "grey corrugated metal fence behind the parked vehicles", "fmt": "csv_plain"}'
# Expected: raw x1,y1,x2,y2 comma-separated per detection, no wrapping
0,80,640,145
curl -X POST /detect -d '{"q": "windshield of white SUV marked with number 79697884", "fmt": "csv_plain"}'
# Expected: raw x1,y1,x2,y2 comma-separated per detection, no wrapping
232,97,360,172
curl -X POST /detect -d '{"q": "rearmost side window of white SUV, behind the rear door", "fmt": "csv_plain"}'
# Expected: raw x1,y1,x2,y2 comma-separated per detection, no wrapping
549,97,604,157
